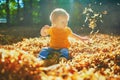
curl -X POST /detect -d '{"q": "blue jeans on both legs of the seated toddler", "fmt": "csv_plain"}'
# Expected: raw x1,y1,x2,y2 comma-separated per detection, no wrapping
39,47,69,59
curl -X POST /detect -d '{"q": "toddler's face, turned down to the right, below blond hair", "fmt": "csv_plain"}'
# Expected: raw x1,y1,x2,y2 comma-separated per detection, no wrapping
55,16,68,28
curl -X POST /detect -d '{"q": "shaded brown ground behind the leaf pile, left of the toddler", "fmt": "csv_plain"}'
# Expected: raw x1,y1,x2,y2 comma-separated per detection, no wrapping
0,26,40,45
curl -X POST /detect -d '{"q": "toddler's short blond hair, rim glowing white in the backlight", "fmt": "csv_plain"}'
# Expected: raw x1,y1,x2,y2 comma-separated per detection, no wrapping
50,8,69,21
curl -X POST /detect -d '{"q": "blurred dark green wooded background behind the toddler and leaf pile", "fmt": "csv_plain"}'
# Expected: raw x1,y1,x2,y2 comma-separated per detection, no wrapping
0,0,120,44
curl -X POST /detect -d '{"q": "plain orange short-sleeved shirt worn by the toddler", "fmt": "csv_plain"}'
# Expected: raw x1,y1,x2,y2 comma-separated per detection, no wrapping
48,27,72,49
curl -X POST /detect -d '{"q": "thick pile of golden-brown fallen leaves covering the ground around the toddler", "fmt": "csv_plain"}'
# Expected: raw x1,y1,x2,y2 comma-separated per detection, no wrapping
0,34,120,80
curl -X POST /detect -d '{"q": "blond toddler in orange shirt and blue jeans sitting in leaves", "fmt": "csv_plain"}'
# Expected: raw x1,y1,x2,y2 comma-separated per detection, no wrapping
39,8,88,60
